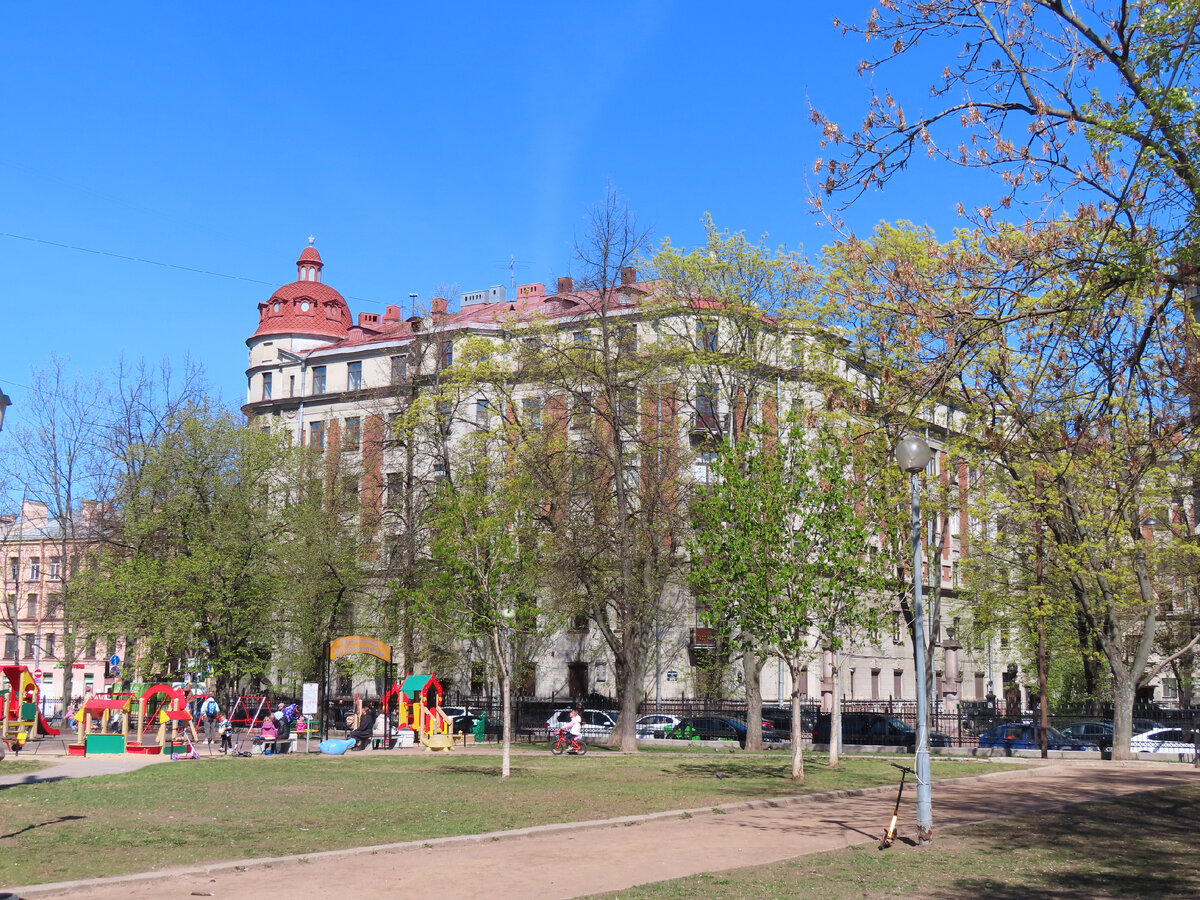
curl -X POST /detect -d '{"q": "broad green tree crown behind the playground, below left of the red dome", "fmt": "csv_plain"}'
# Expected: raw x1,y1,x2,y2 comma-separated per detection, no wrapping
79,403,282,692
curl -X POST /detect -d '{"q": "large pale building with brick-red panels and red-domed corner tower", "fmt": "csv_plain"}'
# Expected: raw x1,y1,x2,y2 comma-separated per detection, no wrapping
242,246,1026,707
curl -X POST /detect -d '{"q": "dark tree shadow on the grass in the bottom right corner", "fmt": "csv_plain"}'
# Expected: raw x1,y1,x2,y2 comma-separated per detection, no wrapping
937,787,1200,900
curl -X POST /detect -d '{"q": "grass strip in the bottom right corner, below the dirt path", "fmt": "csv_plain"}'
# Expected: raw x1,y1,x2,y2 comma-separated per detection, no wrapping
588,786,1200,900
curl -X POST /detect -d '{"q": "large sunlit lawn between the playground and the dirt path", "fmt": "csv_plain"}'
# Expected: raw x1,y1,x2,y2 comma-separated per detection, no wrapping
0,749,1003,884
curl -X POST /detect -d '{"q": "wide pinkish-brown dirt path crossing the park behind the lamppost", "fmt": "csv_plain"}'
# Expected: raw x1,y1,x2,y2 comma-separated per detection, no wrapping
19,763,1200,900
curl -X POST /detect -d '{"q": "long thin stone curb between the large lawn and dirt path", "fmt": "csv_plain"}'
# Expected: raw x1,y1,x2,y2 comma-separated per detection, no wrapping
5,769,1041,899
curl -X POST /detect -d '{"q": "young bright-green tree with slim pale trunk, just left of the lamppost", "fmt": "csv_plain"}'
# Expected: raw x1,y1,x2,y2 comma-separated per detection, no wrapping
690,425,883,779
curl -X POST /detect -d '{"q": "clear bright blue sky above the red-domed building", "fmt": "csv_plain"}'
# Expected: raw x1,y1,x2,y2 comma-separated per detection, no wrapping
0,0,984,417
